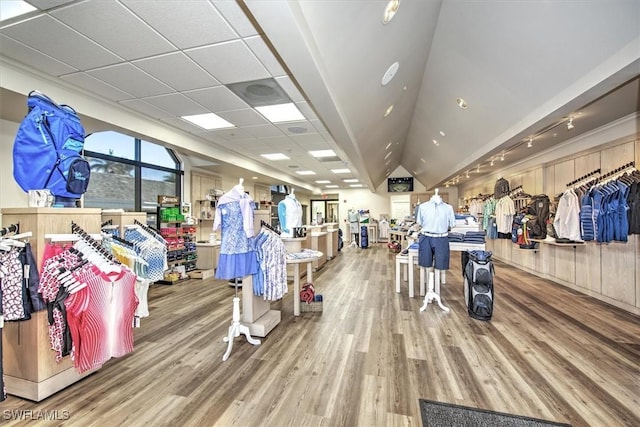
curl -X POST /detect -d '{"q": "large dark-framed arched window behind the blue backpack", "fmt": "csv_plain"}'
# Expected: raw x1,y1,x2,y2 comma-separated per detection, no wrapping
84,131,183,214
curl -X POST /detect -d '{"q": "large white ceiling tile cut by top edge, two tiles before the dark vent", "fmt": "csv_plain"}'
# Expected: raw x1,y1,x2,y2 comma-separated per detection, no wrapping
123,0,236,49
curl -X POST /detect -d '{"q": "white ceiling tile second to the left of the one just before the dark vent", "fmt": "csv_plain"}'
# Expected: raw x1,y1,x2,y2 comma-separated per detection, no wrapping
89,64,173,98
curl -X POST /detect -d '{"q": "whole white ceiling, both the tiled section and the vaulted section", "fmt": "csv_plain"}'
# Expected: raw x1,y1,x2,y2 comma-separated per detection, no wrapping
0,0,640,192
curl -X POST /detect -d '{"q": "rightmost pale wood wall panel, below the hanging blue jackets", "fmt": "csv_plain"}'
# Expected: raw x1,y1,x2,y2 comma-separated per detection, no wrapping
601,242,637,306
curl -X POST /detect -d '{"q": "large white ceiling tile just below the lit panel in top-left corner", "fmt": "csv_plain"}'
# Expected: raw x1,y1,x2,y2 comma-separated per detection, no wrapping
0,15,121,70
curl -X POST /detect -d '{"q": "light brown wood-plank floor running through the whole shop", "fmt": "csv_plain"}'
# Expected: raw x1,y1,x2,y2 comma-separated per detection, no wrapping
0,244,640,427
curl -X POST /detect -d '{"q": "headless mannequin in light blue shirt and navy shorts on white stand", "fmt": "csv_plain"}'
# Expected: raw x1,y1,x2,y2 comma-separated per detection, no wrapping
416,188,456,311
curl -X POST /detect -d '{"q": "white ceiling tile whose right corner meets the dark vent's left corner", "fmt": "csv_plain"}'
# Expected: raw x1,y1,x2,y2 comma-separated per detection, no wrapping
133,52,220,91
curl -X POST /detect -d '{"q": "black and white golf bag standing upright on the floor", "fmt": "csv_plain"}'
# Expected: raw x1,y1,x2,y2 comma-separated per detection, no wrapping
462,251,494,320
